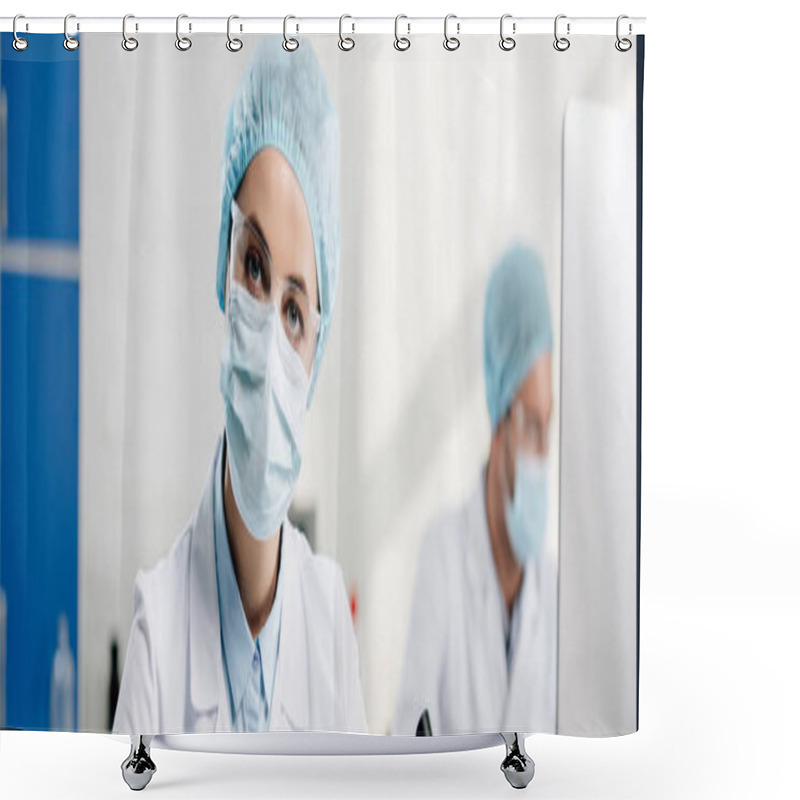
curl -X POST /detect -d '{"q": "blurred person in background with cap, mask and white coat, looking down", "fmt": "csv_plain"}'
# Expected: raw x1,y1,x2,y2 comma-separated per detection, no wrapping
393,246,556,734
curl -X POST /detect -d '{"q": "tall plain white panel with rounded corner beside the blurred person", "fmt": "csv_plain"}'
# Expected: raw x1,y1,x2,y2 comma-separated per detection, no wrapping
558,98,638,736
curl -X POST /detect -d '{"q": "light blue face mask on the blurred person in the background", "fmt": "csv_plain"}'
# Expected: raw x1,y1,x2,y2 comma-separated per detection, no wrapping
504,440,547,566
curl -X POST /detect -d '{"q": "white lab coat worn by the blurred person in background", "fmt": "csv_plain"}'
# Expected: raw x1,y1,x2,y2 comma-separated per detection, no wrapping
393,472,557,735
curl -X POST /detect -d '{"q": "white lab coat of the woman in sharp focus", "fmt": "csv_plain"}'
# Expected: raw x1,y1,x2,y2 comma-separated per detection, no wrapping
113,438,367,734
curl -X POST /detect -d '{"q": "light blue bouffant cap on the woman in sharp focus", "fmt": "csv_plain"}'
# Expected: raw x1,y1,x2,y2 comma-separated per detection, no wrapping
217,36,339,404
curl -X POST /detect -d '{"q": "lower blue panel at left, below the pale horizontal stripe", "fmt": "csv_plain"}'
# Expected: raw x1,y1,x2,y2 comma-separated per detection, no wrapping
0,273,78,730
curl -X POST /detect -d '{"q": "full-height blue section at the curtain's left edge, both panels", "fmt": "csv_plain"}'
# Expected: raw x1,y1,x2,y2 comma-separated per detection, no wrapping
0,34,80,730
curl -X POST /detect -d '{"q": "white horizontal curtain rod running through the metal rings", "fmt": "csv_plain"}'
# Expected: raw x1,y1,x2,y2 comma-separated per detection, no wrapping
0,15,646,36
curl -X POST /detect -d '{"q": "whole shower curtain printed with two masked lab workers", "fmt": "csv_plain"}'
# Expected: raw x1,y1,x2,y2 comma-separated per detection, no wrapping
0,29,643,736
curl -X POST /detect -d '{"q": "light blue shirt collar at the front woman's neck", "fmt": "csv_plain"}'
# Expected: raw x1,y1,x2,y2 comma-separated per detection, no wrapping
214,435,284,717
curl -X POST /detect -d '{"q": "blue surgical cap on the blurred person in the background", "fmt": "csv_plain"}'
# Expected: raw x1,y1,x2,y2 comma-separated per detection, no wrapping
483,245,553,431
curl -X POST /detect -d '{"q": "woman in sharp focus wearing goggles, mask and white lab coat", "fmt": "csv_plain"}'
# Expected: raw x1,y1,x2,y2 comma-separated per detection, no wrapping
114,38,366,735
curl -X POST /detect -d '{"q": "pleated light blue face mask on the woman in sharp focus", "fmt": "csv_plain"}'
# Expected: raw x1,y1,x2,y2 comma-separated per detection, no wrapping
220,280,309,540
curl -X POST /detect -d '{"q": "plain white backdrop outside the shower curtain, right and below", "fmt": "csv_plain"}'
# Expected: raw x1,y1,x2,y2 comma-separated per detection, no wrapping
0,0,800,798
